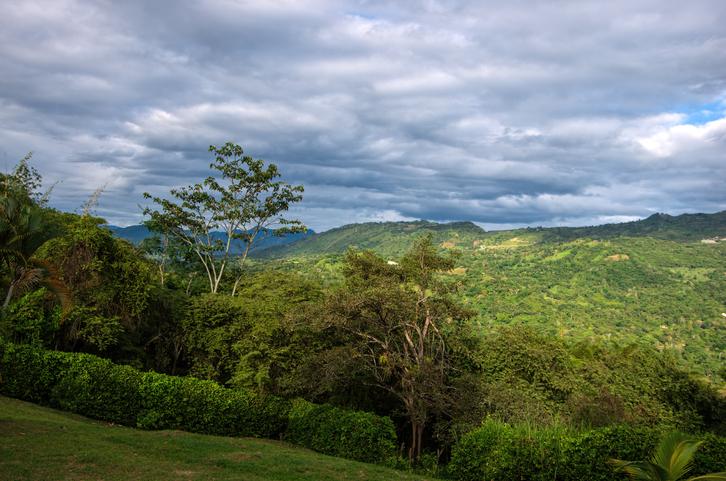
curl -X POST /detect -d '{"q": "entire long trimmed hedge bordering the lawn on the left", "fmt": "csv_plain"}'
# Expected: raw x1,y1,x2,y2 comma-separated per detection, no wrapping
0,339,396,462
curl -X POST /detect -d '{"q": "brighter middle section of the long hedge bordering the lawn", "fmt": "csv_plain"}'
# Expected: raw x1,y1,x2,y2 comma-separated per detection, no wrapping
138,373,290,438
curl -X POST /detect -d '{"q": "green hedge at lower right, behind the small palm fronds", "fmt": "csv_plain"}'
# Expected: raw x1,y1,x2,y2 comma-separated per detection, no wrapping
448,420,726,481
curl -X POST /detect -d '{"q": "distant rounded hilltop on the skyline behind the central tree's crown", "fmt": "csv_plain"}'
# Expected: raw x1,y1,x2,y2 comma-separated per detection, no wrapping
260,220,485,258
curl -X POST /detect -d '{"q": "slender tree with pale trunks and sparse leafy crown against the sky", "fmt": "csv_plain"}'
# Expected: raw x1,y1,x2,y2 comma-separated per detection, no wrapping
144,142,305,294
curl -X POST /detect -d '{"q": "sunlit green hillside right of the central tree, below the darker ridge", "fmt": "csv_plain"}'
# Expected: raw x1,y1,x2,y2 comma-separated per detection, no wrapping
460,237,726,382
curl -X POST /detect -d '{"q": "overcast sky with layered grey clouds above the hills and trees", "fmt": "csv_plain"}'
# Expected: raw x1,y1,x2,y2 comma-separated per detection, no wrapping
0,0,726,230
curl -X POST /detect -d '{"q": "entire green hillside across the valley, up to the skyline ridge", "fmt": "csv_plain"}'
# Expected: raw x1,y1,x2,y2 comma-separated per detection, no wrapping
253,212,726,383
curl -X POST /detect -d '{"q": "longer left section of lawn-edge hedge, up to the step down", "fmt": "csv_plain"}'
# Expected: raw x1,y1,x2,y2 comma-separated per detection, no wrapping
0,343,290,438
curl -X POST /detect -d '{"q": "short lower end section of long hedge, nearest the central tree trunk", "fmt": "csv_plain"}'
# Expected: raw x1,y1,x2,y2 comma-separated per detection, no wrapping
285,399,396,463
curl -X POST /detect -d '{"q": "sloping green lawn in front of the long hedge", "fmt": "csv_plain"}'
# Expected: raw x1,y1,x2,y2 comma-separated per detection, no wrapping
0,396,432,481
